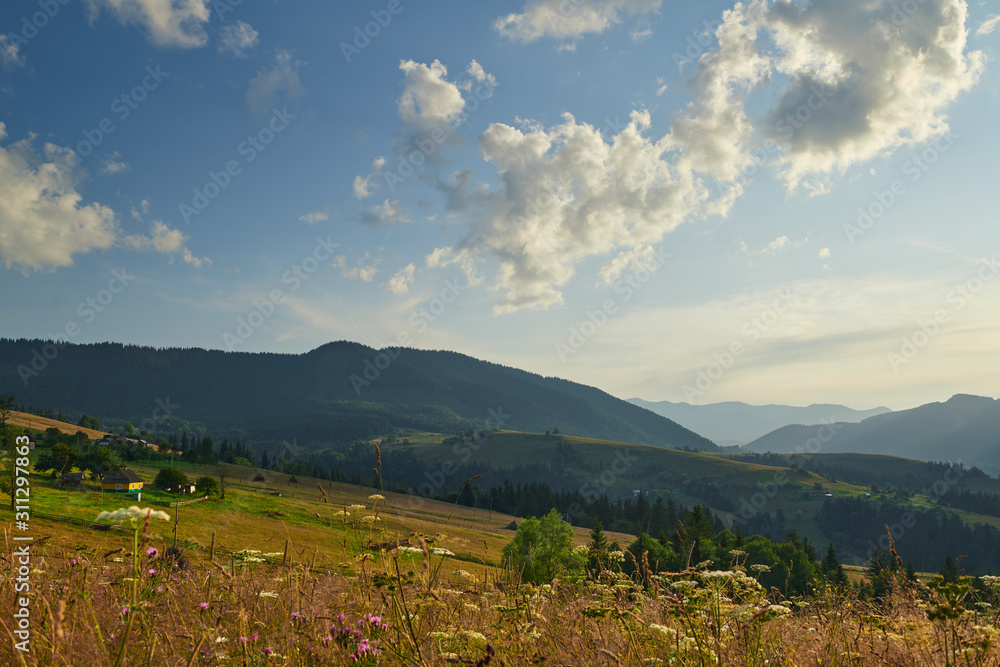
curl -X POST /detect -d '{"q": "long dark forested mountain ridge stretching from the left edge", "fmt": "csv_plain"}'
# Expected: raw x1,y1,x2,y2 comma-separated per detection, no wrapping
0,339,718,451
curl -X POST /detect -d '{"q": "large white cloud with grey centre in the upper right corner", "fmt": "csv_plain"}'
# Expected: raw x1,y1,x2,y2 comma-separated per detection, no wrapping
753,0,985,190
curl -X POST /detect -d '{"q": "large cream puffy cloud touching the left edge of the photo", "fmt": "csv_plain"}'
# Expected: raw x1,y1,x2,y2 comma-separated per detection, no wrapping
0,122,117,270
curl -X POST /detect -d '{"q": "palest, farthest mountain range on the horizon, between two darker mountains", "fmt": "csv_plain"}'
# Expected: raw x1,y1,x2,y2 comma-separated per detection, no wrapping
628,398,891,446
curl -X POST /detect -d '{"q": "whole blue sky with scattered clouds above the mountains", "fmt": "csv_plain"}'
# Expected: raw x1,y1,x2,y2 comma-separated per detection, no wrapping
0,0,1000,409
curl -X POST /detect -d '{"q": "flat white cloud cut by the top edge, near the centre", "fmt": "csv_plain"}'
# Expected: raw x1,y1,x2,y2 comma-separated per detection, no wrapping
493,0,663,42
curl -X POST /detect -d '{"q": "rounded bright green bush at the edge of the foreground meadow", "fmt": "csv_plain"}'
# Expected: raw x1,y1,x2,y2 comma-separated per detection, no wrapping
503,508,583,584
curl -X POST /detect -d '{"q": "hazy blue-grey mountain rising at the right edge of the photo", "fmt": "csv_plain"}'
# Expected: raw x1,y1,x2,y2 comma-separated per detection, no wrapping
746,394,1000,475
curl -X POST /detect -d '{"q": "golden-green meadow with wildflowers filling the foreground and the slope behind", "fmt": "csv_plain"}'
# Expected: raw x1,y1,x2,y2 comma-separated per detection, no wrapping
0,468,1000,667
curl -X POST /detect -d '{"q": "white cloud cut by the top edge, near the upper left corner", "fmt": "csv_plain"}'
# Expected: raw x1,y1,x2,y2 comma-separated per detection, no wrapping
87,0,211,49
